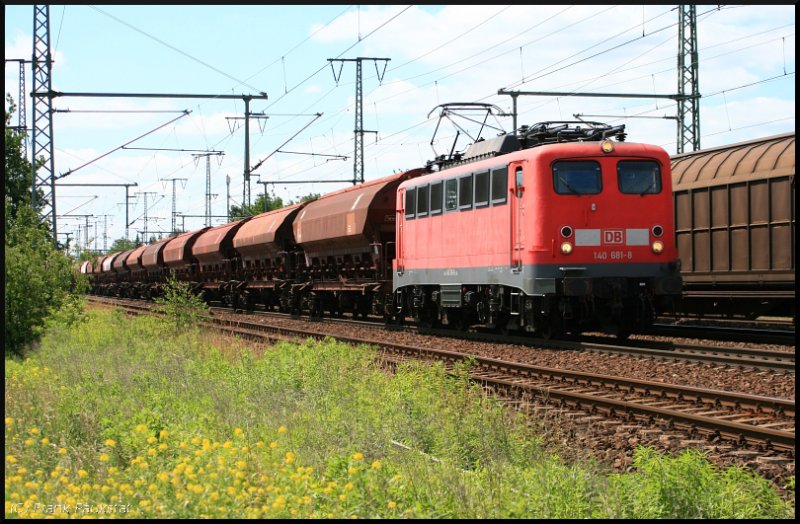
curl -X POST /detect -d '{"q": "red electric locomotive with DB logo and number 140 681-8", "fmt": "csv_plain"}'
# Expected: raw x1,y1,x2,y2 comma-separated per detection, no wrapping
387,122,681,337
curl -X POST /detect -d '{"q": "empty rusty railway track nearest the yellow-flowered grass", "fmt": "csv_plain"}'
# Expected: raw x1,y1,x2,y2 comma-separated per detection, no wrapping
86,296,795,460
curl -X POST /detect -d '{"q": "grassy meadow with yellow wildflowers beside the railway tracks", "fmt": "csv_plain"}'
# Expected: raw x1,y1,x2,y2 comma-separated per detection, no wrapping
5,309,794,518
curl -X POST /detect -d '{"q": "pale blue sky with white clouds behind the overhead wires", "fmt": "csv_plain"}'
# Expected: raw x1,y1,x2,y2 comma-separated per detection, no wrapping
4,4,795,250
